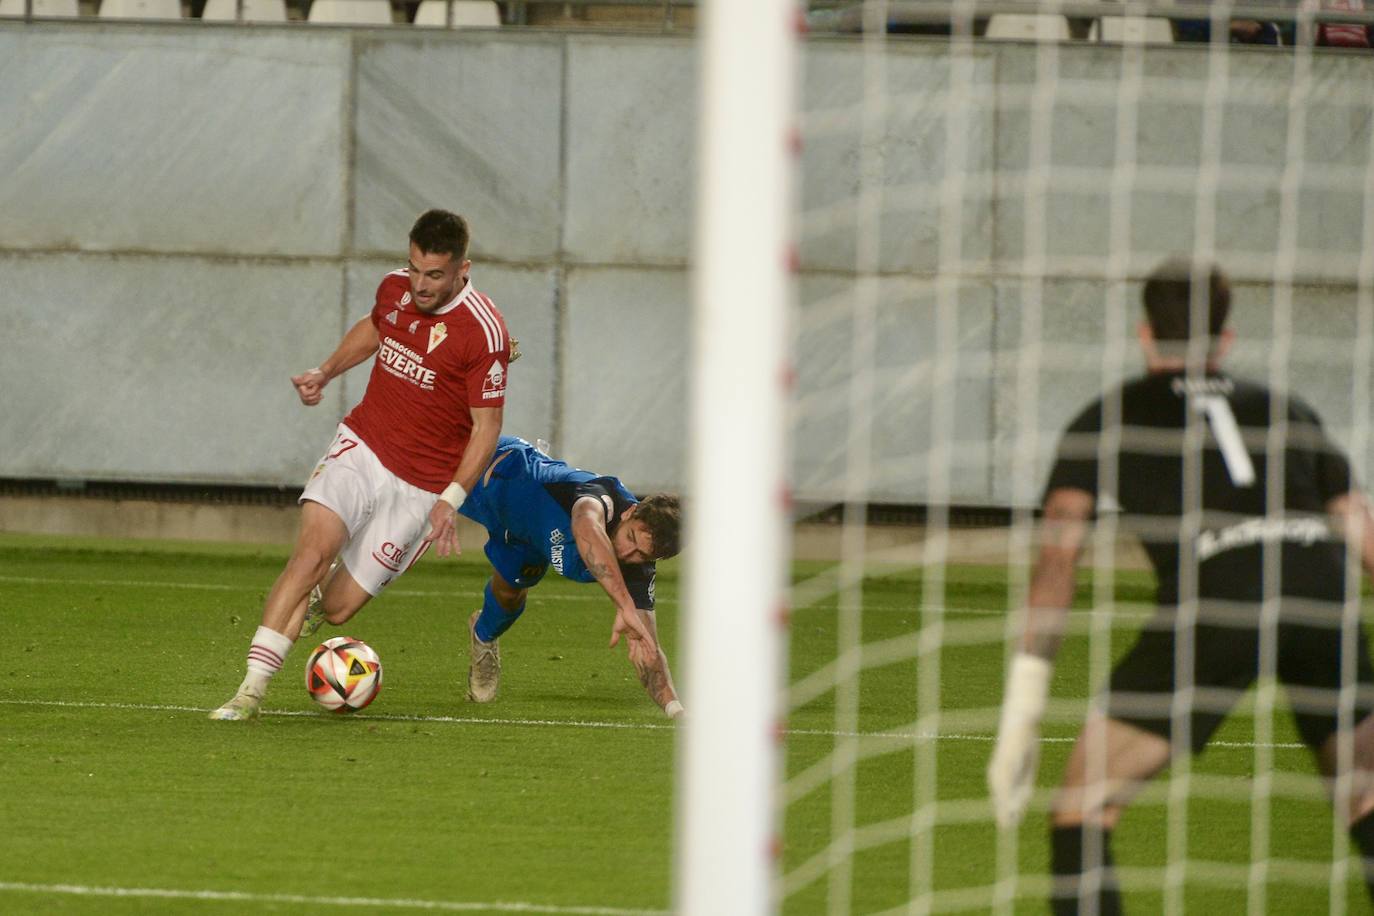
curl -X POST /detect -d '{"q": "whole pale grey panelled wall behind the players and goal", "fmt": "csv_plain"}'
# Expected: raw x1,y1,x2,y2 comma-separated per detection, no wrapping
0,22,1374,505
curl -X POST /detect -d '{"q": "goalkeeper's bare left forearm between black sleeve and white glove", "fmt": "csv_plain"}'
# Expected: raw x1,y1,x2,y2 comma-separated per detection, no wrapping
1021,489,1092,661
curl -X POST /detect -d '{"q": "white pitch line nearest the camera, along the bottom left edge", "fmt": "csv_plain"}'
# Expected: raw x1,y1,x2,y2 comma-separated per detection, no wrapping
0,882,666,916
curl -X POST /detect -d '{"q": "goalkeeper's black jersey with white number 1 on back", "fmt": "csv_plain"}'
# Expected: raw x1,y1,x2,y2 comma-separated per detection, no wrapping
1046,372,1352,604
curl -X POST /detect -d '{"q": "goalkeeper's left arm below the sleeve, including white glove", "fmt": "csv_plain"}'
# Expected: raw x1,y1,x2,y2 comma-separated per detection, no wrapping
988,489,1092,827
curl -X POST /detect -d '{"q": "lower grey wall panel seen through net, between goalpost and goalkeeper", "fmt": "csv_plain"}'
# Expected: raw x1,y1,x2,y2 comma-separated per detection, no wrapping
791,277,995,504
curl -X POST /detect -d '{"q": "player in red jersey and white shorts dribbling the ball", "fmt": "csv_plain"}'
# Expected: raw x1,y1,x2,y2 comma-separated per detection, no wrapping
210,210,513,721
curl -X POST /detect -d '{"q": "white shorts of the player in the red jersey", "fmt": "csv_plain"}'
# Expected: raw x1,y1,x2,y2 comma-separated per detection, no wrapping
300,423,438,596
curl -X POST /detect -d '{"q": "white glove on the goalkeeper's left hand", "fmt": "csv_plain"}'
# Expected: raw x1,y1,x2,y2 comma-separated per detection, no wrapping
988,652,1052,828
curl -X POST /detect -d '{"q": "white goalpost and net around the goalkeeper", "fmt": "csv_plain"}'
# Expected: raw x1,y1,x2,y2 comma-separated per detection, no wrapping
677,0,1374,913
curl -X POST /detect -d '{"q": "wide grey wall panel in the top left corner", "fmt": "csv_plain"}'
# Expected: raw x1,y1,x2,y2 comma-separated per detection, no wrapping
0,23,349,257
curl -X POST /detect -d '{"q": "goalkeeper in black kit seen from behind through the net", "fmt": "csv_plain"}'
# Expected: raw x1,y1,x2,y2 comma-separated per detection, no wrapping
988,260,1374,916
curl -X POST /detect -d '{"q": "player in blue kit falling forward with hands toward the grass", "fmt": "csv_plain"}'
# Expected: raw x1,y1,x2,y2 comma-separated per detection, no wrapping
306,435,683,718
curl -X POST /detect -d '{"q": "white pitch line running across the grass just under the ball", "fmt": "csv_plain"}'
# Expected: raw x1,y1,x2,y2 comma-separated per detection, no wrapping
0,699,1307,750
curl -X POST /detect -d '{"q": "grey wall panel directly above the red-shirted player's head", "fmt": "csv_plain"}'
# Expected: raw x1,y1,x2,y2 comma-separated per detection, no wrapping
354,36,563,261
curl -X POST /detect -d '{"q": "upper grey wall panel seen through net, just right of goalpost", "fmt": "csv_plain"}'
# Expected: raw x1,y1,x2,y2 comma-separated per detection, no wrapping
798,44,996,272
